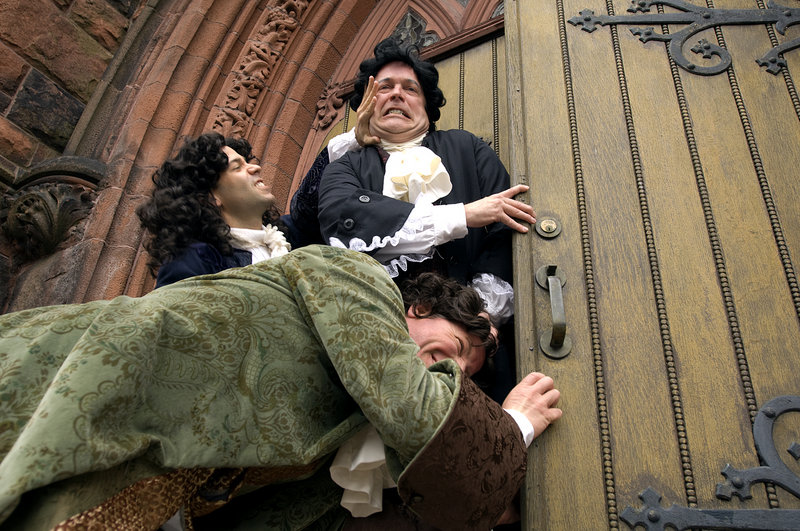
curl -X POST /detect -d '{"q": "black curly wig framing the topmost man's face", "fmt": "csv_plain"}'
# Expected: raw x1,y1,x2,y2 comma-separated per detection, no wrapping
350,37,445,132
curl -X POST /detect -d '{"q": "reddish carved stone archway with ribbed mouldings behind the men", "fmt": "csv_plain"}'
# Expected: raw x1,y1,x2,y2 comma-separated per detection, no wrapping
0,0,502,312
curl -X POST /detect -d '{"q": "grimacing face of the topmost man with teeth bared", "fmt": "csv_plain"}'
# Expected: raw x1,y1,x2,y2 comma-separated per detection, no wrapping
369,61,430,143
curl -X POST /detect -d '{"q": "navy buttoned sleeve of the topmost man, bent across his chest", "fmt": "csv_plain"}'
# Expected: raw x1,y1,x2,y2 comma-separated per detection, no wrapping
319,148,414,252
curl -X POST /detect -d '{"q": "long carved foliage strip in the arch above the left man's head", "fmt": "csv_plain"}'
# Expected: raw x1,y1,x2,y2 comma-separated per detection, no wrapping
213,0,308,136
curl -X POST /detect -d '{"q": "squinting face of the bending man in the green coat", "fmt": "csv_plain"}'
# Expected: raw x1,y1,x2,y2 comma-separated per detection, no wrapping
406,307,486,377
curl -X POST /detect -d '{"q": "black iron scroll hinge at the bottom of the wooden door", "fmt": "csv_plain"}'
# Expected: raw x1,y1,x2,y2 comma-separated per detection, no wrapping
620,396,800,531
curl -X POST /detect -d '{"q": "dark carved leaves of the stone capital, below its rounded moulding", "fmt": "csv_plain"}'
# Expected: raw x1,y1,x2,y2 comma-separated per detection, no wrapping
0,182,93,260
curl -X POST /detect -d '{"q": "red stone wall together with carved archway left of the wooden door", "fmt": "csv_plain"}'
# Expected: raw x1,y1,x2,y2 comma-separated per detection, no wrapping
0,0,502,312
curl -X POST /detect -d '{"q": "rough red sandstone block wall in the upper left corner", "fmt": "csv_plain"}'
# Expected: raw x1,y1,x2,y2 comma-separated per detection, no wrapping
0,0,141,181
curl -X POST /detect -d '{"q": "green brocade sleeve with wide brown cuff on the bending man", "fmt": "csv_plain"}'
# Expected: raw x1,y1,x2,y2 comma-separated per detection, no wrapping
286,246,527,529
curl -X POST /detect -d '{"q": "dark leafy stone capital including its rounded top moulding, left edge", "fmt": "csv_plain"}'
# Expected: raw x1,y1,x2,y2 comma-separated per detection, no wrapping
0,157,106,260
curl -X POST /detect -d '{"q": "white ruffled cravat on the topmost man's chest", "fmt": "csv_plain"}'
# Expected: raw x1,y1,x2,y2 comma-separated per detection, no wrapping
381,133,453,204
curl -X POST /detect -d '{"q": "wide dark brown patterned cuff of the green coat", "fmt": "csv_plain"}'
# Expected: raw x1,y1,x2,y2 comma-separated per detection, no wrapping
397,378,528,530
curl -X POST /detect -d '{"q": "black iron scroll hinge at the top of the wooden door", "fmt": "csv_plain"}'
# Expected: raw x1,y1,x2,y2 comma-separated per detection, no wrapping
569,0,800,76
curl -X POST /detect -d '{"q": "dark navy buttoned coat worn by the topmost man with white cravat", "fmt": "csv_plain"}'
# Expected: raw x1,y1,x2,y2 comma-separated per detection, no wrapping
319,130,512,283
